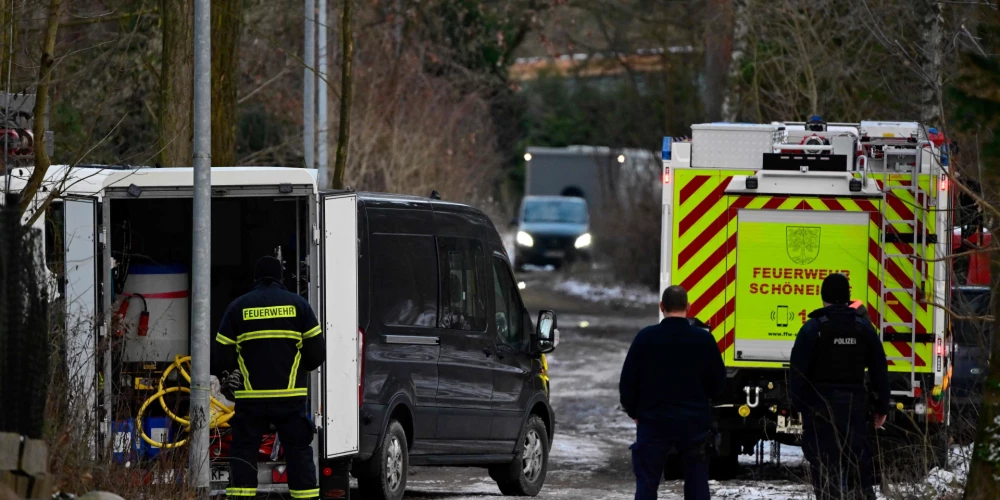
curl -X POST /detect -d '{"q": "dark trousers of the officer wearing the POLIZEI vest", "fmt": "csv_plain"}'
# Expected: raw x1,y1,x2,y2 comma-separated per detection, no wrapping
802,390,875,500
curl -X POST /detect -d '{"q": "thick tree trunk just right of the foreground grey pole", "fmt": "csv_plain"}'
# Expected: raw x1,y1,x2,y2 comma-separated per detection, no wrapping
212,0,244,167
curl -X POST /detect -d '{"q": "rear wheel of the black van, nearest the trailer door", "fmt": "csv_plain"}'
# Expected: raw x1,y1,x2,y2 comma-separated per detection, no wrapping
358,420,410,500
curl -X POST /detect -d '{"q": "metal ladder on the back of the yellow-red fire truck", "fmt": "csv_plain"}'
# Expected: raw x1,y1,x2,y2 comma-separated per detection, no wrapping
872,139,931,398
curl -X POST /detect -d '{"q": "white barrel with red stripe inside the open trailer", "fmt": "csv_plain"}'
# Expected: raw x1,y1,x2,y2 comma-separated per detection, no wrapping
122,264,191,362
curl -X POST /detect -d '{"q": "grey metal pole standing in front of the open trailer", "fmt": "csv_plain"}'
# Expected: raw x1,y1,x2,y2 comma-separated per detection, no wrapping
188,0,212,496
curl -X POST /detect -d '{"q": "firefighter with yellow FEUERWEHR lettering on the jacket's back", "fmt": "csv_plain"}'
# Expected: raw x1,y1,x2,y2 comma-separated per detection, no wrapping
213,257,325,499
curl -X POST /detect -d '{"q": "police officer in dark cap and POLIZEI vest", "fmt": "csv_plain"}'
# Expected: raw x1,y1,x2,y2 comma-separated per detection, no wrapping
790,274,889,500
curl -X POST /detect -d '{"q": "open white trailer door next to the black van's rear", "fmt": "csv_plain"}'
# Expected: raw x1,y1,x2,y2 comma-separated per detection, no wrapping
320,193,361,460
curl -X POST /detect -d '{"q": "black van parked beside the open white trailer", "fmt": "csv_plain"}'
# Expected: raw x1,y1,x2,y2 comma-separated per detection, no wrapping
340,194,558,500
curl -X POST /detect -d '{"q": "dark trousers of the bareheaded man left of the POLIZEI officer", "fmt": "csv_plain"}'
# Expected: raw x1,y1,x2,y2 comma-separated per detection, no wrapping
631,421,710,500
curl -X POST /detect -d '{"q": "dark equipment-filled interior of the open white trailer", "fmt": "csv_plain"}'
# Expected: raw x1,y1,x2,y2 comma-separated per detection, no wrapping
100,195,310,459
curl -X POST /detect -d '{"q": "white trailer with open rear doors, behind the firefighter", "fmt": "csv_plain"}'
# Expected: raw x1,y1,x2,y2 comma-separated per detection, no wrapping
12,166,360,497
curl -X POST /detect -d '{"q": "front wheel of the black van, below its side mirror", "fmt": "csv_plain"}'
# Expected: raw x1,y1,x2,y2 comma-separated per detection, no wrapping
490,415,549,497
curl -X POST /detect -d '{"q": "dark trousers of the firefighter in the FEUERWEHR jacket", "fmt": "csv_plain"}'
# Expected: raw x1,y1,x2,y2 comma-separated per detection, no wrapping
226,399,319,499
